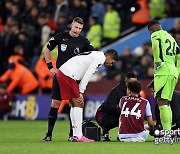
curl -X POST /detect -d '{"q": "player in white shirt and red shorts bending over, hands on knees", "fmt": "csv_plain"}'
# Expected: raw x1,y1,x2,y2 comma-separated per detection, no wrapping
57,49,118,142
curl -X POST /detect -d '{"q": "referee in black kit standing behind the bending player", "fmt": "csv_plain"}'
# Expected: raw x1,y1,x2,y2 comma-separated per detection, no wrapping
42,17,94,141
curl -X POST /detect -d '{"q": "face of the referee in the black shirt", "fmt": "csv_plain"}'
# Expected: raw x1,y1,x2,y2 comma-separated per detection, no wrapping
70,22,83,37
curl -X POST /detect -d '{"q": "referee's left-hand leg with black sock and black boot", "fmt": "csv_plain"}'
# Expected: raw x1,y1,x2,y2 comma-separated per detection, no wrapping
42,77,61,141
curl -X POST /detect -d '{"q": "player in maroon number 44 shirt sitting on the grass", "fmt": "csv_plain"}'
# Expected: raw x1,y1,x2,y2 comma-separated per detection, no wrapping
118,81,154,142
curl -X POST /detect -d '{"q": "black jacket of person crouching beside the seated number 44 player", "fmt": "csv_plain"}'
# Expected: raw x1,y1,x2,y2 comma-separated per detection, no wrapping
100,78,127,115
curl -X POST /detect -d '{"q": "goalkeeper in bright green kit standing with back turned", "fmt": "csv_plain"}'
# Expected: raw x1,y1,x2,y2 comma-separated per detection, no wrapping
148,21,180,130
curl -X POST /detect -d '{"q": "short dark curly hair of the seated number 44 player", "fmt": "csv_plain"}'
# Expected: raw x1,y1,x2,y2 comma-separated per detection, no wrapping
127,80,142,94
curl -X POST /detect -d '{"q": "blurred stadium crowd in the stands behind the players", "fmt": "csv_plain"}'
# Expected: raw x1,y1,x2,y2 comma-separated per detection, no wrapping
0,0,180,94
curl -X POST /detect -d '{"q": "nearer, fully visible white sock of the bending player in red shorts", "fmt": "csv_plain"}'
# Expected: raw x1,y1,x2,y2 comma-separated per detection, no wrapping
74,107,83,138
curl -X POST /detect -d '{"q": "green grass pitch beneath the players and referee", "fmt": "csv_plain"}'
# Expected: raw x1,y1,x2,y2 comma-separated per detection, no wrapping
0,121,180,154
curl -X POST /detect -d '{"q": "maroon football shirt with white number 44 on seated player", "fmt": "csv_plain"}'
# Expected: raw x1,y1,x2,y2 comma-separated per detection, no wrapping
119,96,148,134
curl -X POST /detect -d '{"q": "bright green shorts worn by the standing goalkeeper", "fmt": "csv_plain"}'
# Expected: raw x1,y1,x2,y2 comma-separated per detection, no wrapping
154,75,178,101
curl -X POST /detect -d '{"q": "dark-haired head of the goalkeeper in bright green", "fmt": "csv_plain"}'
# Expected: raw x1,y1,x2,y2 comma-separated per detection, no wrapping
147,20,162,34
